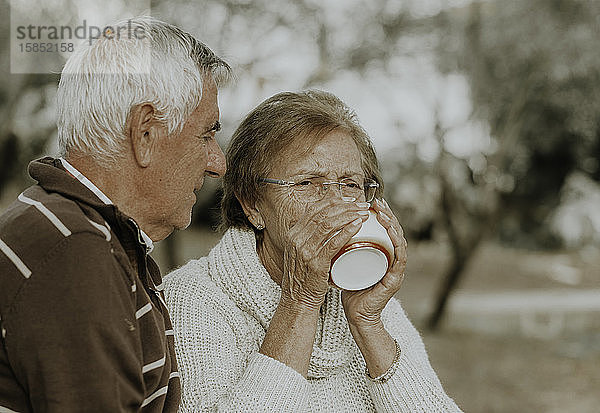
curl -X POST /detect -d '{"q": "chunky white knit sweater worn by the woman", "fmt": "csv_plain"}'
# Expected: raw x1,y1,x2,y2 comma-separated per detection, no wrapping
165,229,460,413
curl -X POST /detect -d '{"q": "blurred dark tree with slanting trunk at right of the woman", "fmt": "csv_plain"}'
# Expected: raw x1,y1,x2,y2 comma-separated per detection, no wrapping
429,0,600,328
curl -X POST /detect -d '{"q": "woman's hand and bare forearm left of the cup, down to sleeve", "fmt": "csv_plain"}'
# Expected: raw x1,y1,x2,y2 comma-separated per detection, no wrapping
260,198,368,377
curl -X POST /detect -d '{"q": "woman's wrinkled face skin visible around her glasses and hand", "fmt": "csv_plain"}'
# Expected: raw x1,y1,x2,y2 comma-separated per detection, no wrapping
256,129,365,257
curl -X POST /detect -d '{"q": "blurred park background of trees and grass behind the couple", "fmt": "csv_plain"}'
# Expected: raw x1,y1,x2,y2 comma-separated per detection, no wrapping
0,0,600,412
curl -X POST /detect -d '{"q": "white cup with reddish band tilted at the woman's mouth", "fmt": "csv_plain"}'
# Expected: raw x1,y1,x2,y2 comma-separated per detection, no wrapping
329,209,394,291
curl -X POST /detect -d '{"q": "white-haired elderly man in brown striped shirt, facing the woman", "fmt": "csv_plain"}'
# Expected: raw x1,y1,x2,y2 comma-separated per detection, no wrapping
0,18,230,412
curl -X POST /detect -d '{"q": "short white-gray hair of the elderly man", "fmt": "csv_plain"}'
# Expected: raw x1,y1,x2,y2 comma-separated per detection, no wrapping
57,17,231,162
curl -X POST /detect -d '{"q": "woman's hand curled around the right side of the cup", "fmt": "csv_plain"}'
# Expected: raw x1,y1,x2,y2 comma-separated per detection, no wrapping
342,200,407,331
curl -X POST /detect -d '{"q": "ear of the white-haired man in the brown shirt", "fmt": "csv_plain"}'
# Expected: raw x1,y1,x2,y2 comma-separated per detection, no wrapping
127,103,162,168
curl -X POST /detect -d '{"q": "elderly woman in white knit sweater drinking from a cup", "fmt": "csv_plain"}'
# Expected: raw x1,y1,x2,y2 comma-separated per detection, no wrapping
165,91,460,412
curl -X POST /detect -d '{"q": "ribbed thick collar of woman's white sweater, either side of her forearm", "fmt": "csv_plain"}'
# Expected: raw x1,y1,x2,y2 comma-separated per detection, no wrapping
208,228,356,378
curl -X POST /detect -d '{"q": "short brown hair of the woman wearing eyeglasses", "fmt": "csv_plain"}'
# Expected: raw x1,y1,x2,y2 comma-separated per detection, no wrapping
221,90,383,230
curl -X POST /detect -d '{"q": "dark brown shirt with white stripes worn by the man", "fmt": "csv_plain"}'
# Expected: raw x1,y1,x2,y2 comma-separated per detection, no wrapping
0,158,180,412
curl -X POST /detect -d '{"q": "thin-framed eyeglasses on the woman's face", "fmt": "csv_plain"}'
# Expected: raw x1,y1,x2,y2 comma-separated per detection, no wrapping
259,178,379,202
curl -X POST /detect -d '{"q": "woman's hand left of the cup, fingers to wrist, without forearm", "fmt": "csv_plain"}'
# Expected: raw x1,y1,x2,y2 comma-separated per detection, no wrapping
281,197,368,309
